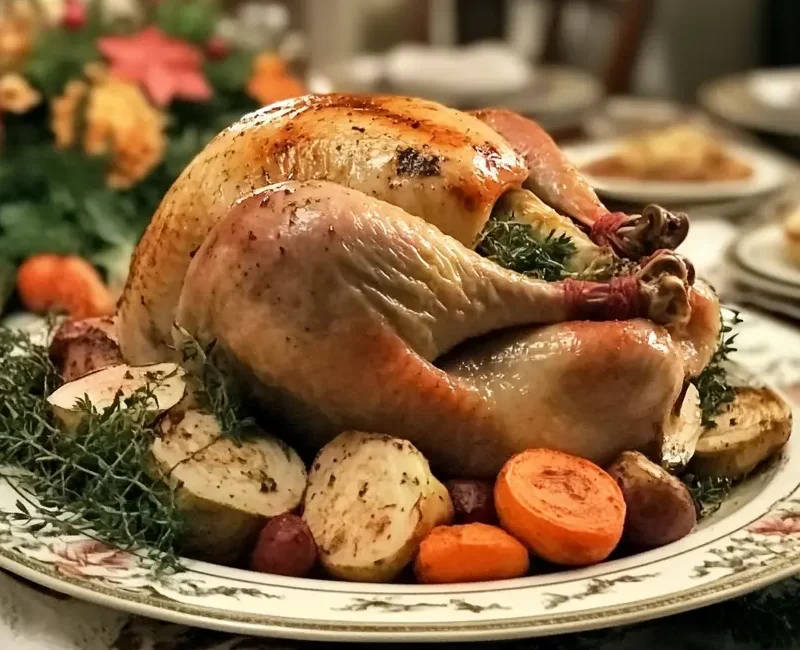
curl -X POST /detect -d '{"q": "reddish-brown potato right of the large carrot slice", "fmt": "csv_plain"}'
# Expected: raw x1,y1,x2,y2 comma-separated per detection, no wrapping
608,451,697,549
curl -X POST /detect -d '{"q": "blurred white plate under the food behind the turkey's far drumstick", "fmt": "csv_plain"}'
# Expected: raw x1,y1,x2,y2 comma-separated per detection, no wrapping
564,140,788,203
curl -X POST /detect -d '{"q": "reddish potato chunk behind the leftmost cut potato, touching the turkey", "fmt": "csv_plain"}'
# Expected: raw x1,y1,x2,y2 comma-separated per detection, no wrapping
50,317,123,382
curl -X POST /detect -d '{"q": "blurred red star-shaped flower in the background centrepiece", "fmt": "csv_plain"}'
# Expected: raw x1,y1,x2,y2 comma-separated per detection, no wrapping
97,27,213,106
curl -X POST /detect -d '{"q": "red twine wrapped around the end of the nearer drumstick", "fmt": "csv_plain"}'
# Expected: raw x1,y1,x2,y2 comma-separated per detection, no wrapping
563,276,645,320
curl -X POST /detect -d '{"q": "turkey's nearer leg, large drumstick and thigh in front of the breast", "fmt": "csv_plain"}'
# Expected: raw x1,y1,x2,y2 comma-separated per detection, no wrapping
177,182,688,476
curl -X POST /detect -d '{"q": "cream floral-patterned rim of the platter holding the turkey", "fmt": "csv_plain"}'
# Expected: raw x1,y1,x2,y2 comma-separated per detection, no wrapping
0,362,800,642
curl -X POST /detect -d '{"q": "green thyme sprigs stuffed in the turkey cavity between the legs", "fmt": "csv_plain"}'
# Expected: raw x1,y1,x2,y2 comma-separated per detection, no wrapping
476,212,576,282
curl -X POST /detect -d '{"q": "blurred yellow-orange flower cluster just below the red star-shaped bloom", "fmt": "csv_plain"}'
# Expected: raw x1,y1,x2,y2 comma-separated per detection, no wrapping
51,75,166,188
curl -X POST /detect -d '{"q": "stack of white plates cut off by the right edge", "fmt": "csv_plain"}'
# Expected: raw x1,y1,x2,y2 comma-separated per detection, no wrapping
727,223,800,320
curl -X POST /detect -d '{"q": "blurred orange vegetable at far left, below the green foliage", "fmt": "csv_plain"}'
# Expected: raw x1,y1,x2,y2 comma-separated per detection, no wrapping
17,254,114,318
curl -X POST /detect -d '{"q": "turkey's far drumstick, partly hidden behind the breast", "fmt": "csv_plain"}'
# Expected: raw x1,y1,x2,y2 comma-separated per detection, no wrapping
473,108,689,259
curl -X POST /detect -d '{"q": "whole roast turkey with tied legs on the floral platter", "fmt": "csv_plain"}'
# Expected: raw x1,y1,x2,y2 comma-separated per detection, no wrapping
117,95,720,477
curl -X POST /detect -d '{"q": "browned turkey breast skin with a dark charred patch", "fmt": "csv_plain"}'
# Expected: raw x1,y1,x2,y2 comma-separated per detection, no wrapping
119,95,528,363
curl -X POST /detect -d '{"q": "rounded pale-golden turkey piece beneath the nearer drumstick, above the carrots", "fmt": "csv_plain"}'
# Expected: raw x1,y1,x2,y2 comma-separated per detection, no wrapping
437,320,684,466
